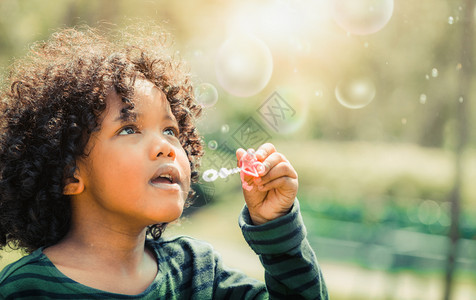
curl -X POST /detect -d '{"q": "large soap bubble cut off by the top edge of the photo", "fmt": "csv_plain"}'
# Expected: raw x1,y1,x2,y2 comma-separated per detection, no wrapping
332,0,393,35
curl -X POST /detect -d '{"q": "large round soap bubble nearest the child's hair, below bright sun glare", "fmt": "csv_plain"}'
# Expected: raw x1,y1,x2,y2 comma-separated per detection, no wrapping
215,34,273,97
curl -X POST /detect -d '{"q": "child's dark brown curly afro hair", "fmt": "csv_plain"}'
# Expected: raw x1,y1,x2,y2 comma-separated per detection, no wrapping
0,26,203,252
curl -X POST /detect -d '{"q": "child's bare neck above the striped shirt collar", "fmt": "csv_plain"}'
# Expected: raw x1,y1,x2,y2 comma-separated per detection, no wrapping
44,222,157,294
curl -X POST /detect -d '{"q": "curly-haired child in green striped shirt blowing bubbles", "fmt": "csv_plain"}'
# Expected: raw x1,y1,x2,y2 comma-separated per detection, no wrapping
0,28,327,299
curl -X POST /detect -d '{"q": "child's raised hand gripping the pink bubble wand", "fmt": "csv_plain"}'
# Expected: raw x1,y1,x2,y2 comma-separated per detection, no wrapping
236,143,298,225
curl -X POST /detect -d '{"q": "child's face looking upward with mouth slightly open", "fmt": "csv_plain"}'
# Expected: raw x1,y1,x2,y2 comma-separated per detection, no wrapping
78,80,190,226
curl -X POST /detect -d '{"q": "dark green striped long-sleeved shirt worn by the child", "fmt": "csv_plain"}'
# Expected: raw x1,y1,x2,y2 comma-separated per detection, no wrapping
0,200,328,299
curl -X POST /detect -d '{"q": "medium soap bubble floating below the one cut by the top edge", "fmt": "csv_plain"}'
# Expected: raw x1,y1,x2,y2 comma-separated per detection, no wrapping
335,77,375,109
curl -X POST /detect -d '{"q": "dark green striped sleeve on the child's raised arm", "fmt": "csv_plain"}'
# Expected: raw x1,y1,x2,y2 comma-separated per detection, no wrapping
239,199,329,299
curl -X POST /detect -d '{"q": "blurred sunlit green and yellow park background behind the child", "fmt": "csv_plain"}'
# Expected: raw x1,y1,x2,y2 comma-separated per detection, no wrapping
0,0,476,299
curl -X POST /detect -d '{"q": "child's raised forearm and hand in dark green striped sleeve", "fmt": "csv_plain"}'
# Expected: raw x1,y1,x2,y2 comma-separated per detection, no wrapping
233,144,328,299
